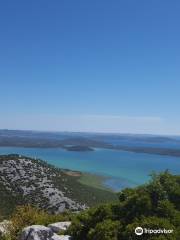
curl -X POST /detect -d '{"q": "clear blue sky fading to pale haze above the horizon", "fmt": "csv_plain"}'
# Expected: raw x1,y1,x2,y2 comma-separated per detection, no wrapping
0,0,180,134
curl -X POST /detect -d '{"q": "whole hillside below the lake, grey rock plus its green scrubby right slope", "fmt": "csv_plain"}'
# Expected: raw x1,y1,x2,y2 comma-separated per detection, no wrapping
0,155,116,219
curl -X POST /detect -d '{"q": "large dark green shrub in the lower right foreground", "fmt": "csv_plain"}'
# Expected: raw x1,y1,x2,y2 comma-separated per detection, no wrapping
67,171,180,240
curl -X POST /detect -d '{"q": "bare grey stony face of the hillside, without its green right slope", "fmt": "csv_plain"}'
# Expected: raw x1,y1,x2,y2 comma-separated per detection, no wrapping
0,155,86,213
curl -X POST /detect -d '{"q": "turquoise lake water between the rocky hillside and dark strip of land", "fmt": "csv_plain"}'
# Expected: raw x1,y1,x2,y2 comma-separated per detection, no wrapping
0,147,180,190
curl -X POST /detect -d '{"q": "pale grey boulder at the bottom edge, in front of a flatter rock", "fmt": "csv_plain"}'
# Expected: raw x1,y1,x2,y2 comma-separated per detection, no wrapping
19,225,71,240
